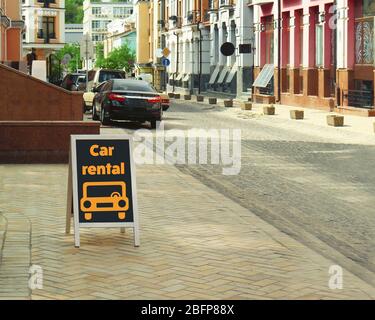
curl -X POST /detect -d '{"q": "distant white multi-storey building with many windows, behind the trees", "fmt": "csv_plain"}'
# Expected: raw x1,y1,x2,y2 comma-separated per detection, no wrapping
83,0,133,46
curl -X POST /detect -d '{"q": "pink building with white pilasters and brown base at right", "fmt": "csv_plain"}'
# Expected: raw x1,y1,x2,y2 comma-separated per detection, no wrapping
252,0,375,115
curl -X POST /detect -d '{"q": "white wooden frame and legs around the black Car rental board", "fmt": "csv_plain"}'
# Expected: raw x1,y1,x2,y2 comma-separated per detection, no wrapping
65,134,140,248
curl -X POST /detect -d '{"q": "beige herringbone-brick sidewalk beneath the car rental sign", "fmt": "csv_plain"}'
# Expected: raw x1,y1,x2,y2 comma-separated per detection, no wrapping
0,165,375,299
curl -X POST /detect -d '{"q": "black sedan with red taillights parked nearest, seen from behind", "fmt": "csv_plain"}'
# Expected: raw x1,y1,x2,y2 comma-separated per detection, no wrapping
92,79,163,129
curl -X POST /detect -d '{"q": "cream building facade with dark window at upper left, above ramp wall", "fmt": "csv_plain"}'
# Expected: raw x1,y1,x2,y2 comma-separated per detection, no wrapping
22,0,65,60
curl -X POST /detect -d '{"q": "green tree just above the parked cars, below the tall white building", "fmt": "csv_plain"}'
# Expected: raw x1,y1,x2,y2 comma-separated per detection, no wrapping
95,44,135,72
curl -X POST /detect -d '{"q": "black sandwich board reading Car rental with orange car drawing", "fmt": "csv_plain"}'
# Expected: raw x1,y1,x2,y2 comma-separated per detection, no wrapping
66,135,139,247
